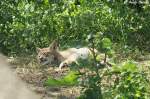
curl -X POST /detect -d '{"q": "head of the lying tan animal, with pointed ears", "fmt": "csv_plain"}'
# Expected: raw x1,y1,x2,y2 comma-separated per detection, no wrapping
37,40,58,65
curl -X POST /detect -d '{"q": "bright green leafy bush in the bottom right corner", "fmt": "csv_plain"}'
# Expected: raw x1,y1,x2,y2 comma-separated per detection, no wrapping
105,61,149,99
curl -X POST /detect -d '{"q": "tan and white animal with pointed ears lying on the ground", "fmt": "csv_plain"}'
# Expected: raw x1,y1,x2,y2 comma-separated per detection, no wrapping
37,41,98,69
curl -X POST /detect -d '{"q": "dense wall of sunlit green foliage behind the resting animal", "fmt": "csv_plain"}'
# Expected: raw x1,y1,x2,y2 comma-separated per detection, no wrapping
0,0,150,55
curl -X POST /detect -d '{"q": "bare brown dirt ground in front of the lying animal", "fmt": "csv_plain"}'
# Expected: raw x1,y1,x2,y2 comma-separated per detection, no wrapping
8,57,80,99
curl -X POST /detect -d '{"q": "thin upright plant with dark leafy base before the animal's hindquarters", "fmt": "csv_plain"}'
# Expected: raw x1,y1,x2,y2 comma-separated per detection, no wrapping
79,34,105,99
